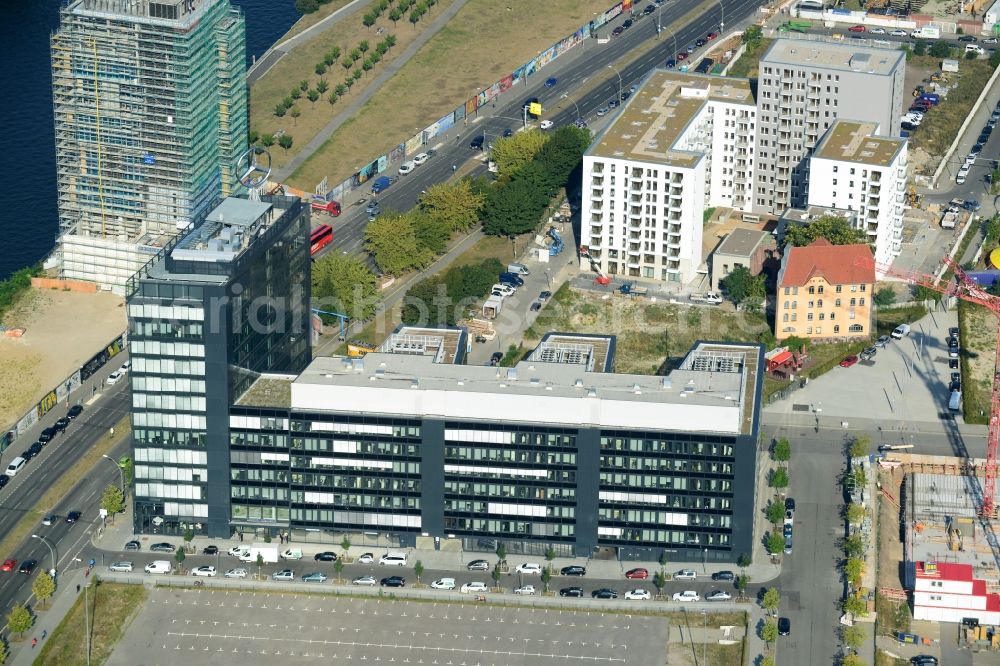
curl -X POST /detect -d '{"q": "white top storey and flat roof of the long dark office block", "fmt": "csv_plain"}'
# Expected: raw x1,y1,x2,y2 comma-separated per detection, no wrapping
291,343,759,435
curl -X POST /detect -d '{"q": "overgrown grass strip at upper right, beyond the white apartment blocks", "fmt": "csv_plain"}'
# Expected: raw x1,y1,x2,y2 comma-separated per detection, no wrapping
907,56,993,168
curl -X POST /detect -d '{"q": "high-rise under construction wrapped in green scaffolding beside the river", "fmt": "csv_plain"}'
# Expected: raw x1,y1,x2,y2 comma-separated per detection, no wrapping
52,0,247,289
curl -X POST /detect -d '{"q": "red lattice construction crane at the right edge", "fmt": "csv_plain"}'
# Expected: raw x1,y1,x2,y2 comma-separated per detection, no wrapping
873,257,1000,568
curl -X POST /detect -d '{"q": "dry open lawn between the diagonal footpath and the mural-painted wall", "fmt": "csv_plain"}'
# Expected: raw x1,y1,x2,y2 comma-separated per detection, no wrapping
286,0,608,189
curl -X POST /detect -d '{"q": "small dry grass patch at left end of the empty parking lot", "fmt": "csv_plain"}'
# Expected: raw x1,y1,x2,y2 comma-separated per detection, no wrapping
35,581,149,666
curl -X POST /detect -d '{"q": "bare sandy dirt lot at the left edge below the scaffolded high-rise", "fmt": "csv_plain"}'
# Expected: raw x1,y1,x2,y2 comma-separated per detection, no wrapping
0,289,126,427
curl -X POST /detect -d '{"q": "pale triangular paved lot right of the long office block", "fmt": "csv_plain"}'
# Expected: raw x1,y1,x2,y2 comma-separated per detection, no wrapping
768,310,961,426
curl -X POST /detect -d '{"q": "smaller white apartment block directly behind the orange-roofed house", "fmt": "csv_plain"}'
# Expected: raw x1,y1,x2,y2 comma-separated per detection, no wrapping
808,120,907,277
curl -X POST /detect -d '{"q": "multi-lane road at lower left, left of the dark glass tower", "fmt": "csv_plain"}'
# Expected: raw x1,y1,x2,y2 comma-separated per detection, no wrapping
0,382,131,614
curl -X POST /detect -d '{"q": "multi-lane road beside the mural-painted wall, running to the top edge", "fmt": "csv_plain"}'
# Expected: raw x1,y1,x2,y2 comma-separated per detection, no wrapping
314,0,765,254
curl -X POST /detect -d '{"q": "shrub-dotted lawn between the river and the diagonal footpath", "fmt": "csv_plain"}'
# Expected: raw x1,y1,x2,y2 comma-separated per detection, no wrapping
250,3,445,175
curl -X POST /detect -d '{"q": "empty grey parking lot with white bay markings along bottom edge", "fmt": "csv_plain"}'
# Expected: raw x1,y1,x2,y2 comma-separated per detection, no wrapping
108,588,667,666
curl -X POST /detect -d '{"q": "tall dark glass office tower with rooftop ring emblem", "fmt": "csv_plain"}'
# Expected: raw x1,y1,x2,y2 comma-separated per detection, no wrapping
127,197,311,535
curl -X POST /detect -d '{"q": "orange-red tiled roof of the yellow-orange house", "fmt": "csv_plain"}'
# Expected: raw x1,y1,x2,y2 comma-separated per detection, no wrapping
778,238,875,287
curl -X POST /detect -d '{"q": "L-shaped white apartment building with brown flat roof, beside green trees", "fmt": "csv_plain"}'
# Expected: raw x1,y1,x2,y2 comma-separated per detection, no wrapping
580,70,756,284
